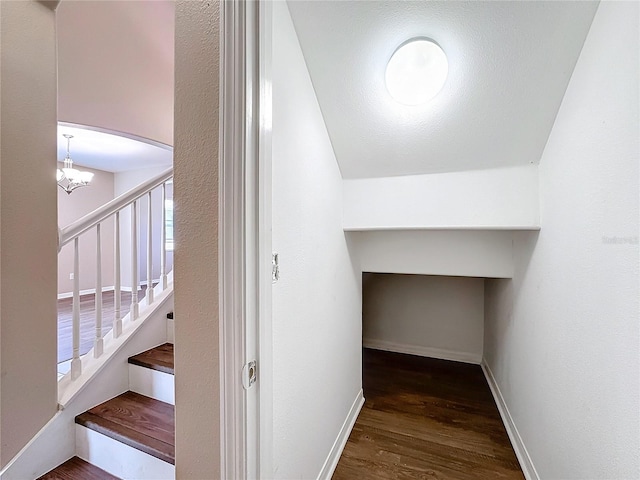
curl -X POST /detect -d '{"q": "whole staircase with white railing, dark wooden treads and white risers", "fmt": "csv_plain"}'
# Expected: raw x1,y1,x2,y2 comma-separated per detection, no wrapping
0,169,175,480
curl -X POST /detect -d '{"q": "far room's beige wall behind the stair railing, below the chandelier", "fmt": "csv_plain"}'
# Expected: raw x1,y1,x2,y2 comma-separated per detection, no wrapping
58,163,114,294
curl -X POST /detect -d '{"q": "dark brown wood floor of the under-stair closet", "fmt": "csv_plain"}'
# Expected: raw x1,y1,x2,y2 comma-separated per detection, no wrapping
333,349,524,480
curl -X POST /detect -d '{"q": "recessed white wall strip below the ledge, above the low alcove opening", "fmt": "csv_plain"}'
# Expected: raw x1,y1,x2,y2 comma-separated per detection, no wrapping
356,230,513,278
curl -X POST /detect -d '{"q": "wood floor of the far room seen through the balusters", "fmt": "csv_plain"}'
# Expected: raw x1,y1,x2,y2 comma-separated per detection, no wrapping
58,286,147,363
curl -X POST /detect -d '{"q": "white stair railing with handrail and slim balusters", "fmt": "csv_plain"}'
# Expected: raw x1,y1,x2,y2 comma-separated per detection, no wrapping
58,168,173,380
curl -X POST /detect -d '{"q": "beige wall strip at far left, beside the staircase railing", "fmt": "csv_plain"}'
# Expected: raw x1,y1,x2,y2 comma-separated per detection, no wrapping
0,2,58,468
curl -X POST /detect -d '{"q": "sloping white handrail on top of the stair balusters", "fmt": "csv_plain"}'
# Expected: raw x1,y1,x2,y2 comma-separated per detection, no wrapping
58,168,173,251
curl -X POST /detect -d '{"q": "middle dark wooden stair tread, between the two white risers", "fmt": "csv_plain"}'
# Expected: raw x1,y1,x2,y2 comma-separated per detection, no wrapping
76,392,175,465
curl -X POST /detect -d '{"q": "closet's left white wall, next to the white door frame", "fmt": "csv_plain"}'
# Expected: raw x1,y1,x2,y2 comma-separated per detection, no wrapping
273,2,362,480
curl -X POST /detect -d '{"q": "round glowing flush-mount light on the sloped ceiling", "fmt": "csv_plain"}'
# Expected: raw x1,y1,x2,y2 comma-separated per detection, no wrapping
385,38,449,105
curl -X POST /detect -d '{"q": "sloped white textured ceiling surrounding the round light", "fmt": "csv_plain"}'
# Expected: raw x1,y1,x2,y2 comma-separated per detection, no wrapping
288,1,597,178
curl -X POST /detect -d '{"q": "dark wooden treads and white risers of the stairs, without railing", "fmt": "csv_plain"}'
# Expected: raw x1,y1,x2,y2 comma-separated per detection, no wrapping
40,332,175,480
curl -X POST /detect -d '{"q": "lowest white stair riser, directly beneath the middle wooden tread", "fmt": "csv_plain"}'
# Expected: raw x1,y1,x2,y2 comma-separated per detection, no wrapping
76,425,176,480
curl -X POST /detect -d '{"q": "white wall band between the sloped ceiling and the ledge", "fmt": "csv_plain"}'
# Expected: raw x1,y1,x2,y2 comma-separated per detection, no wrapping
343,165,539,230
